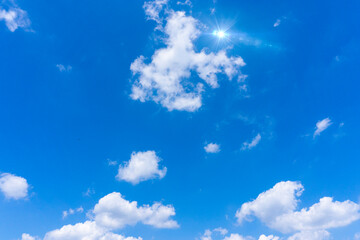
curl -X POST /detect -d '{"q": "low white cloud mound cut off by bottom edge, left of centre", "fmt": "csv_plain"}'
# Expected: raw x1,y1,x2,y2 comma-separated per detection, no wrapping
44,221,142,240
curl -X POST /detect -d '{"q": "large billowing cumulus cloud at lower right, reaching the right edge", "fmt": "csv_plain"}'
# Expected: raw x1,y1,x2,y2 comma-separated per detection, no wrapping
236,181,360,234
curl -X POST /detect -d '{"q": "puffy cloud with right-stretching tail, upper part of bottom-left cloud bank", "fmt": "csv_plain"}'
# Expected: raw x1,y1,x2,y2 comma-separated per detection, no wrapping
93,192,179,229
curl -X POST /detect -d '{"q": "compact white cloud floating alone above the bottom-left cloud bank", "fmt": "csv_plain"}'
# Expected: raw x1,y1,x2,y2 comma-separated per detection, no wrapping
116,151,167,184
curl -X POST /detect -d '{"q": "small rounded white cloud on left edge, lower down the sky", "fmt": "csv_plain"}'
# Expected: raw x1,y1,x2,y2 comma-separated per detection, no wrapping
0,173,29,200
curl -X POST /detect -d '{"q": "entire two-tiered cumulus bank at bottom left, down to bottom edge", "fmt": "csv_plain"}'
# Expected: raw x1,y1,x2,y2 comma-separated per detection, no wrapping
22,192,179,240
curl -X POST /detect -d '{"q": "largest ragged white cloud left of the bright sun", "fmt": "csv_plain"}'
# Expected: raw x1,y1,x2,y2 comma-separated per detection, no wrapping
130,11,245,112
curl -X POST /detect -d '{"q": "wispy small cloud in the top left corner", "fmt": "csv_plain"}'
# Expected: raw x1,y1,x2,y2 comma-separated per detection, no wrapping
0,6,31,32
